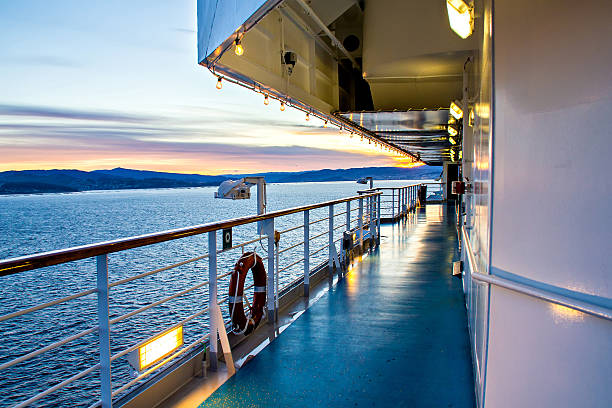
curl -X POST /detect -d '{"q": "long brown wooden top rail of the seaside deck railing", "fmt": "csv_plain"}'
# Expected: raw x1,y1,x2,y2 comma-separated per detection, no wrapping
0,192,382,276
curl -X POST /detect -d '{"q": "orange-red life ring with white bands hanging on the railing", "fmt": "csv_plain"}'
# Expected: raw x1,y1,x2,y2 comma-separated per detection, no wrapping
229,252,266,335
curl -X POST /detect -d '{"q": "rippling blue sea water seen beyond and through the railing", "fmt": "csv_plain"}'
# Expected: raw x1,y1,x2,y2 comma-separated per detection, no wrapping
0,181,420,407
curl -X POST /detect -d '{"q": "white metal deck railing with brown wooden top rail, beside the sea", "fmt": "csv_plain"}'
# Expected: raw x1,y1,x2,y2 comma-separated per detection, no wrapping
0,190,378,407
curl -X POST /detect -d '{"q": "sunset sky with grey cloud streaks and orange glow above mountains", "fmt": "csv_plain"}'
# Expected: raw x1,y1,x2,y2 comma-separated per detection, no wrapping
0,0,406,174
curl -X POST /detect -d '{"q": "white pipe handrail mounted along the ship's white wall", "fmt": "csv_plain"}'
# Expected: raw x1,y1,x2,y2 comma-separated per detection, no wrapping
461,226,612,320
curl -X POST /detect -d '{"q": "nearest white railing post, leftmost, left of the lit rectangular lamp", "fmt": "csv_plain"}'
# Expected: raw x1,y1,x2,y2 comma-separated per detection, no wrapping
96,254,113,408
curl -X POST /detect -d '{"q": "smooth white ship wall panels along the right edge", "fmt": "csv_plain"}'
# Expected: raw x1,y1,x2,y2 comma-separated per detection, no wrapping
484,0,612,408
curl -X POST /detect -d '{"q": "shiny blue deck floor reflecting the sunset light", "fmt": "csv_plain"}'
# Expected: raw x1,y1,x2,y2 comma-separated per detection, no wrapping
201,205,475,407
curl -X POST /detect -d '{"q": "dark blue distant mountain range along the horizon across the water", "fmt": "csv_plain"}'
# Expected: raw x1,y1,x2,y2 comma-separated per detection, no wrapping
0,166,441,194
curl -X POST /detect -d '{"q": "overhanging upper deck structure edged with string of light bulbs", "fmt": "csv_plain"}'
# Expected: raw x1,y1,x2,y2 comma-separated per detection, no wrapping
198,0,475,165
